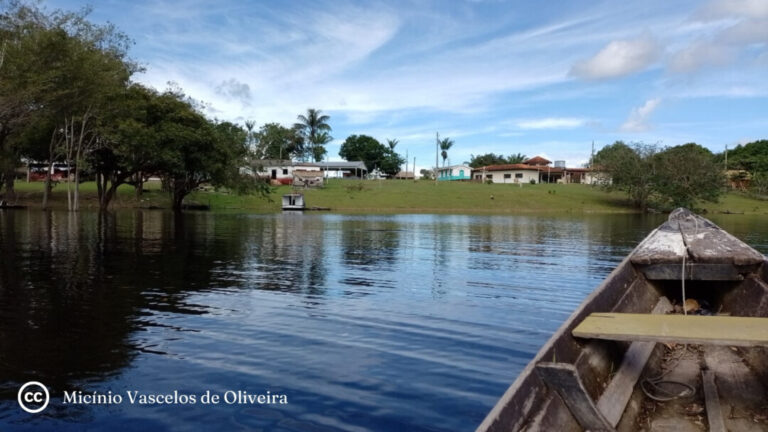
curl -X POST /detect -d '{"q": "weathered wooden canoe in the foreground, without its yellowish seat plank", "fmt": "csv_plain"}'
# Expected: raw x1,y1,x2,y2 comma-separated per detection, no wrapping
477,208,768,431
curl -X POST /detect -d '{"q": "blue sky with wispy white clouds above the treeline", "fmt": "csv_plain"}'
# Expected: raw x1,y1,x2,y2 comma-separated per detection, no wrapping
47,0,768,172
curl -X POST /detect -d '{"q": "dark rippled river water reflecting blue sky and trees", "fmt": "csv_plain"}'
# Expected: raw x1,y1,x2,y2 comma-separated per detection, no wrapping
0,210,768,432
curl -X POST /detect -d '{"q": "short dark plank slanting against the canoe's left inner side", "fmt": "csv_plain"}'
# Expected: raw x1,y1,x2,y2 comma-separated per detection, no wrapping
536,362,615,431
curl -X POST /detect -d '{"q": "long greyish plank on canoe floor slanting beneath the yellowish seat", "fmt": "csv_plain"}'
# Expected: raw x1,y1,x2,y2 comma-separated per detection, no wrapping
597,297,672,427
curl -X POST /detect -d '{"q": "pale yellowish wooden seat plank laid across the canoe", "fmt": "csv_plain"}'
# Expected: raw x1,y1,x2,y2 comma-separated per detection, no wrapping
572,313,768,346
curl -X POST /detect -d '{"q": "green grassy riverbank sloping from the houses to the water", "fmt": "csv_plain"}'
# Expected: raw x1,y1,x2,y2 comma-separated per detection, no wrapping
6,180,768,214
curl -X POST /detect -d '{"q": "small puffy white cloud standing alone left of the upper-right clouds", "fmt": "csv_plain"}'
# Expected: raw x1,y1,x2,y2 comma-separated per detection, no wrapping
570,37,661,79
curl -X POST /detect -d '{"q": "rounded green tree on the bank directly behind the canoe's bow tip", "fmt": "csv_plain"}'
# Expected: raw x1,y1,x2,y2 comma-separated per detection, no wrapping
653,143,725,208
